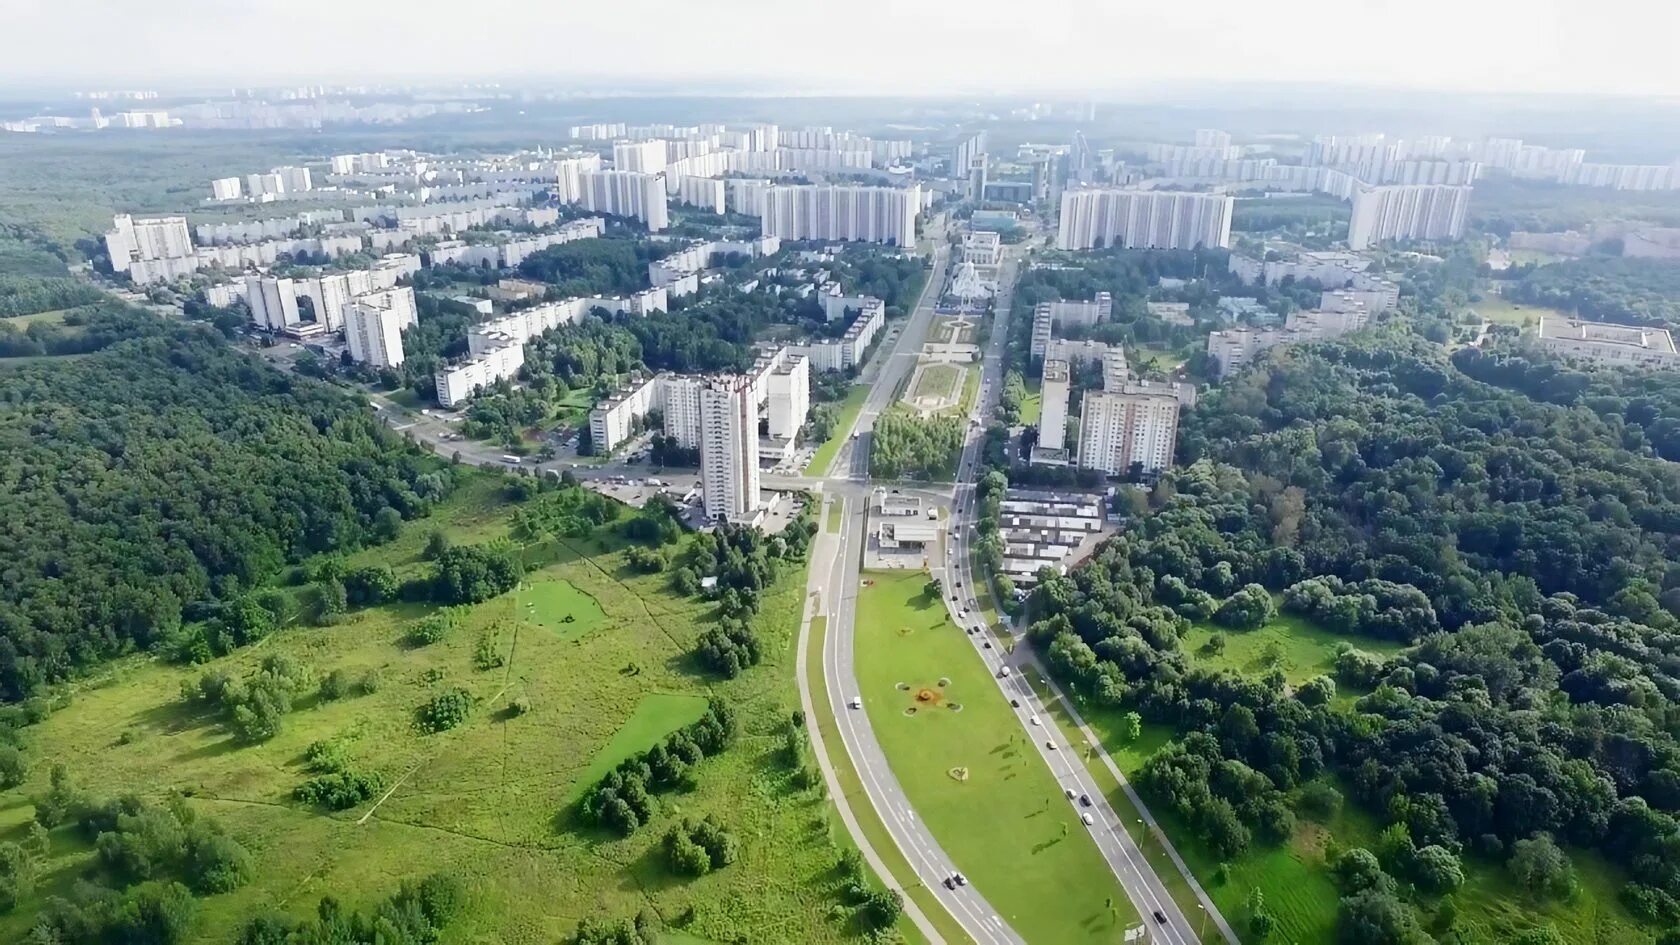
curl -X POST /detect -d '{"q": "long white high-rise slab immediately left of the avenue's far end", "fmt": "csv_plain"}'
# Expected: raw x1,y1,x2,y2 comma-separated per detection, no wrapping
761,185,922,247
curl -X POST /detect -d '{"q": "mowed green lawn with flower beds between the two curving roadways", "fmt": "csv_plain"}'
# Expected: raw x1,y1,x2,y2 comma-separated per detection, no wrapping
857,572,1136,945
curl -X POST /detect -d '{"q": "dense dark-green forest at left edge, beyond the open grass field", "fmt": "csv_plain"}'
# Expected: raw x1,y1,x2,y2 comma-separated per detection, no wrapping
0,309,449,700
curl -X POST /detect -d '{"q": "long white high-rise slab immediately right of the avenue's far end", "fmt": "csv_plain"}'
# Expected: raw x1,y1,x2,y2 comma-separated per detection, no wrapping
1057,190,1235,249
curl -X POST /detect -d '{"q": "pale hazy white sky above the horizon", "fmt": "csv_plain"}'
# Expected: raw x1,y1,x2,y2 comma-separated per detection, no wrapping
13,0,1680,96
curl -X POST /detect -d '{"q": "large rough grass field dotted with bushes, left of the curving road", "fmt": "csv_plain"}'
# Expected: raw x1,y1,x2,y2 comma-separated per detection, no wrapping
0,476,893,945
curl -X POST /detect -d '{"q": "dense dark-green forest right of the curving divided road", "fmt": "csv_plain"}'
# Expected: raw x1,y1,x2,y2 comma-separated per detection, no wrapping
1030,331,1680,945
